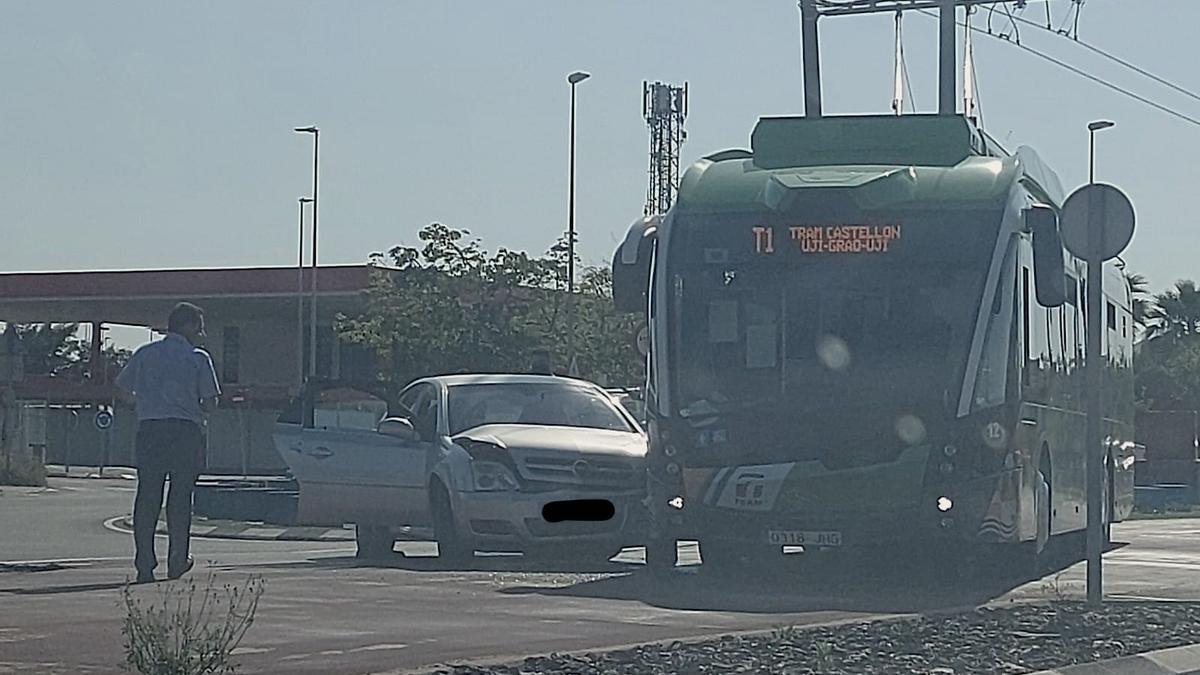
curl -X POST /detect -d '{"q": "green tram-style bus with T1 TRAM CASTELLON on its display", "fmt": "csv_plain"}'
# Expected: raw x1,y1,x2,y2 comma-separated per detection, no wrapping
613,115,1134,565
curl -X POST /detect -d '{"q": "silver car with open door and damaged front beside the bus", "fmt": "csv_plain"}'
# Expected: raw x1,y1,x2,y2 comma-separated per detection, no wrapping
275,375,647,562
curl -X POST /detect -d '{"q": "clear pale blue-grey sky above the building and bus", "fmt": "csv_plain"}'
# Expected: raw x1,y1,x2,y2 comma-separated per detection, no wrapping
0,0,1200,287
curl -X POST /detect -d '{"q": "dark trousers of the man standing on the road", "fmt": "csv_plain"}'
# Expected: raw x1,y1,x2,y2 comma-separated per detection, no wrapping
133,419,204,577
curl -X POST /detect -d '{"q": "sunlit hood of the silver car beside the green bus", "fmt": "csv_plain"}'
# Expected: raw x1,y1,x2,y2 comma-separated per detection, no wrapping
455,424,647,458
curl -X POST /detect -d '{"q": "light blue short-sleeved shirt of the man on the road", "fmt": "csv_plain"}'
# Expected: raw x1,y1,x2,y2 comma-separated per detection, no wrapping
115,333,221,425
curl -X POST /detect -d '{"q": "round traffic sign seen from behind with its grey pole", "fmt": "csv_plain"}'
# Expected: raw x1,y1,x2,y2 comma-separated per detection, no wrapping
1062,183,1134,605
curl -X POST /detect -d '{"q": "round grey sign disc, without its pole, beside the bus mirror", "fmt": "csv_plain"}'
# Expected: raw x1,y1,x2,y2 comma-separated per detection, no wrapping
1060,183,1134,261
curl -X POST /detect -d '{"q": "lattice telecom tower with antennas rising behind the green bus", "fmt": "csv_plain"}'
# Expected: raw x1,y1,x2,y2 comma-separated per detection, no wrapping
642,82,688,215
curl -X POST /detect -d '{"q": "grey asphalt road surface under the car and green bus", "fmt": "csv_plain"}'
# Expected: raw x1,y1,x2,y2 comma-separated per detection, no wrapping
0,479,1200,674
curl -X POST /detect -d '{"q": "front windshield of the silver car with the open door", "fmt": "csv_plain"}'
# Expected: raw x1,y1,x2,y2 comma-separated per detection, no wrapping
448,383,634,435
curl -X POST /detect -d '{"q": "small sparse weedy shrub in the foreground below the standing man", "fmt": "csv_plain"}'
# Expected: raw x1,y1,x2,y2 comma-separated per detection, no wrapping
121,575,265,675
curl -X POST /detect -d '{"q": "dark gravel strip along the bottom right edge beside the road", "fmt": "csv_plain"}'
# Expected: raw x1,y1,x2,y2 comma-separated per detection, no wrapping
432,602,1200,675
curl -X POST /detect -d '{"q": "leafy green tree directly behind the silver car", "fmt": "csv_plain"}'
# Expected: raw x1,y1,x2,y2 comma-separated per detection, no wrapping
337,223,644,400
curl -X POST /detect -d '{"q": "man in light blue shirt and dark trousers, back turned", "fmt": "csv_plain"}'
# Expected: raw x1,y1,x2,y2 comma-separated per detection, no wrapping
115,303,221,584
